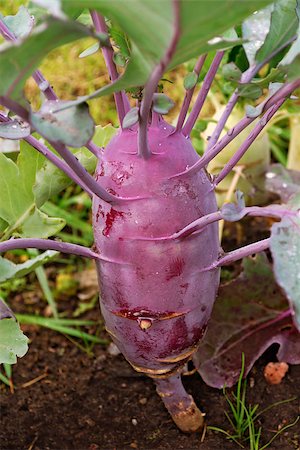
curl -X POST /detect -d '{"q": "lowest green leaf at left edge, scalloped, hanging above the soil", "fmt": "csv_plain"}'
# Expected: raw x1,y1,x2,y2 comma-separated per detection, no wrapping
0,298,29,364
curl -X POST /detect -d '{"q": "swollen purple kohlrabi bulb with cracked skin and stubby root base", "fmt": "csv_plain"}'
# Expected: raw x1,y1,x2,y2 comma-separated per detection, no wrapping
93,119,219,432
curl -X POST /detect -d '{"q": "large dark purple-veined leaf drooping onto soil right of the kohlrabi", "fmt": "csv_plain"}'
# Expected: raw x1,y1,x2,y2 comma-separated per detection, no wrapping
193,253,300,388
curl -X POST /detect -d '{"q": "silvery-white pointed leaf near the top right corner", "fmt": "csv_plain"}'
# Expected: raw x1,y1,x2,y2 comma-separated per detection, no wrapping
242,5,273,65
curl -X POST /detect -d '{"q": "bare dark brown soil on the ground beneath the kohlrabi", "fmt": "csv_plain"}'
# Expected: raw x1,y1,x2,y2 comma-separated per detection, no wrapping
0,217,300,450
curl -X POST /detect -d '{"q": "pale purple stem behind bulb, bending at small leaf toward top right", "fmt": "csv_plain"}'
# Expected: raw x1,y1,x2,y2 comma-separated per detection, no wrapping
206,36,296,151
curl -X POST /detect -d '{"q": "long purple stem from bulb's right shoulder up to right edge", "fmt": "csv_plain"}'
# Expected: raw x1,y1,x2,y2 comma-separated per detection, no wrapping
170,79,300,178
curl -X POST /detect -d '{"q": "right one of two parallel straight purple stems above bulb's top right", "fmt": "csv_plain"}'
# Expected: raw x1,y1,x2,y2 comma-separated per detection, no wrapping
182,51,225,136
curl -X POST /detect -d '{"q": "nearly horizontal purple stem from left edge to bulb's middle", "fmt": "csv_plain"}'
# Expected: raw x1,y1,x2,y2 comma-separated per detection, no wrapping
0,238,100,259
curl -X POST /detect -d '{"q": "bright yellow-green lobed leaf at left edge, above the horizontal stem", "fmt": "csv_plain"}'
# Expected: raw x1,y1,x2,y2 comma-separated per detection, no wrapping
0,143,65,239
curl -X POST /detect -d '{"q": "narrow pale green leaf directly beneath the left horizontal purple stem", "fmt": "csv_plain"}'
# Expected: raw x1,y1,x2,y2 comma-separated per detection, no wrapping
0,250,59,283
